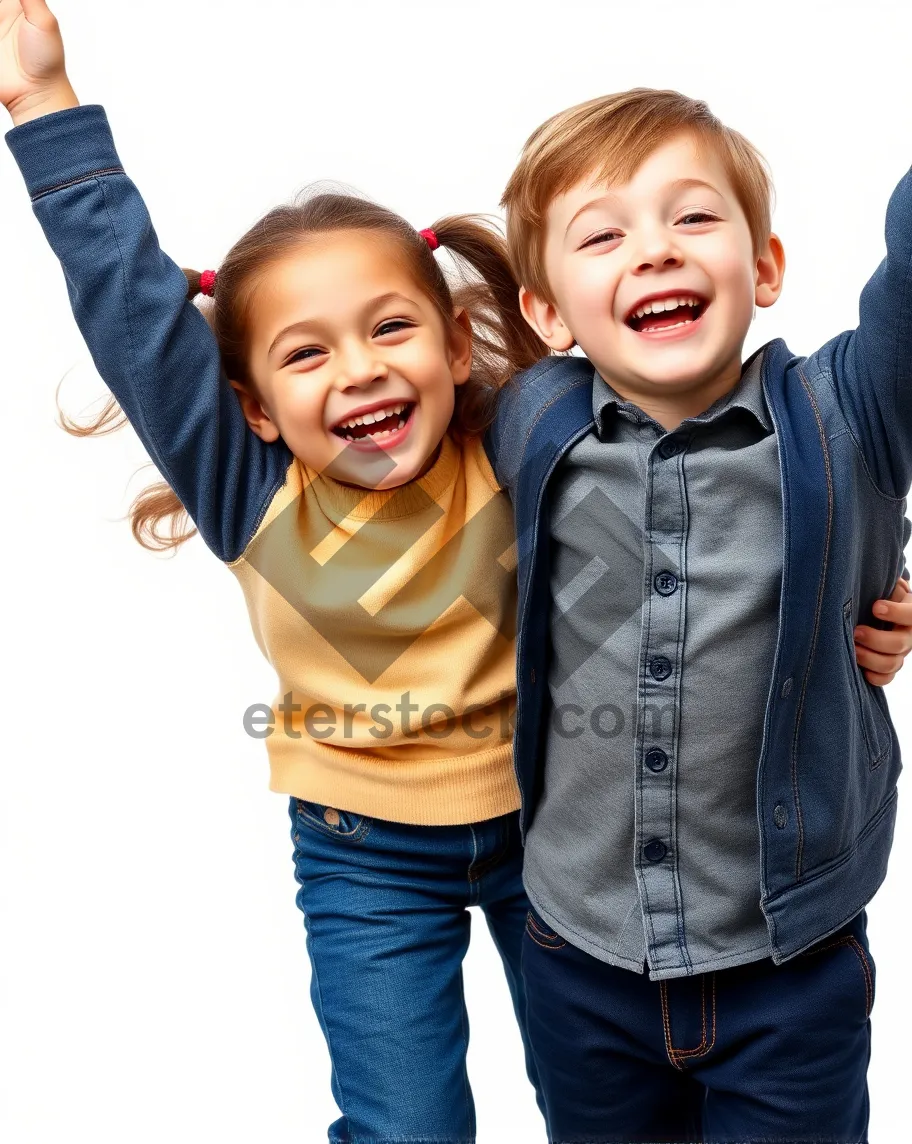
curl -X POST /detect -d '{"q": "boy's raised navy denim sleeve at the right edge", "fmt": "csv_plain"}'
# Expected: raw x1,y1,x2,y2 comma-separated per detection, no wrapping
811,162,912,498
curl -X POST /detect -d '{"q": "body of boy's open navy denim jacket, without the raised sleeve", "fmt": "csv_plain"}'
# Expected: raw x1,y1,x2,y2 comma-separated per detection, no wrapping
487,335,912,963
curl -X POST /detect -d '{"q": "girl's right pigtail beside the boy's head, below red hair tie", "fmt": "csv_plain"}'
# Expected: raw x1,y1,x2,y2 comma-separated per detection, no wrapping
430,215,552,436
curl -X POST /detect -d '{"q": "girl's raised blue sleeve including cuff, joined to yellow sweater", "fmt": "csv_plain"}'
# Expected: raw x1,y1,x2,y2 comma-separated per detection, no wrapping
6,104,292,561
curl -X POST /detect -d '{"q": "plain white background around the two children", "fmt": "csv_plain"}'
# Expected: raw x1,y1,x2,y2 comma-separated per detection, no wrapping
0,0,912,1144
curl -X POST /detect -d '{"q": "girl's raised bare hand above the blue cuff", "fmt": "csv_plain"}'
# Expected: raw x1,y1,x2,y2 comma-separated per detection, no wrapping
0,0,79,127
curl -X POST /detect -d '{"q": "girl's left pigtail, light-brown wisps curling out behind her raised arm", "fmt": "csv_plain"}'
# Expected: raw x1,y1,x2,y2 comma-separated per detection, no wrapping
54,270,208,551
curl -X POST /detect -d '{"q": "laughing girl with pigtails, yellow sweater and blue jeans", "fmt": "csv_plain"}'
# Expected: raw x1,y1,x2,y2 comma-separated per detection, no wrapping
0,0,910,1144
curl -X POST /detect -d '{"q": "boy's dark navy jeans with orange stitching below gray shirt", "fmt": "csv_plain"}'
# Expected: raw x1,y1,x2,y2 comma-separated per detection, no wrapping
523,911,874,1144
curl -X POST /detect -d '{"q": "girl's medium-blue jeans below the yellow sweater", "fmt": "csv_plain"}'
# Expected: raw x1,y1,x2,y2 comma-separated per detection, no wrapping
284,799,534,1144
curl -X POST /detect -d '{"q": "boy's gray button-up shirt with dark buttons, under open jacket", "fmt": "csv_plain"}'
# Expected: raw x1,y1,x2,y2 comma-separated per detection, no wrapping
525,353,783,979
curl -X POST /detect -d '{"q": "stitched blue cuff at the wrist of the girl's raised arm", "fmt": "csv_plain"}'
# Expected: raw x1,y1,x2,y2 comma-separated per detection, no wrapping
5,103,124,200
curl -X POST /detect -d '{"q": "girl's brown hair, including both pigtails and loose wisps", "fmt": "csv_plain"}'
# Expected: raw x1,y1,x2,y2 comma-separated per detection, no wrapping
57,192,549,550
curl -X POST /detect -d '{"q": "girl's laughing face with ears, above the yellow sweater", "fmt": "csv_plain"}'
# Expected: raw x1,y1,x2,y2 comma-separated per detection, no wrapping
232,230,471,488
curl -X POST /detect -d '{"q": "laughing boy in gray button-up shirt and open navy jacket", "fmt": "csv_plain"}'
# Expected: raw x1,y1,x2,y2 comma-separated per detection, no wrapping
492,89,912,1142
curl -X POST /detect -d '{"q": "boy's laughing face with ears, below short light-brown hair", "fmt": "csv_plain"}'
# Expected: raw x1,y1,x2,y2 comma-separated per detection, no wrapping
522,132,785,428
